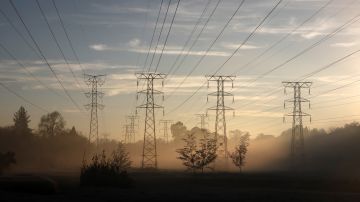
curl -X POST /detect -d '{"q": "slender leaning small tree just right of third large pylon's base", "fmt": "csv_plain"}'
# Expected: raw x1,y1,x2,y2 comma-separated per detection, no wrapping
230,133,250,172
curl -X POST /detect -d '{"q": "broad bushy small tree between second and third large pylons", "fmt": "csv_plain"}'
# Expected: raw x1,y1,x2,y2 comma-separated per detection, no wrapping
176,133,217,172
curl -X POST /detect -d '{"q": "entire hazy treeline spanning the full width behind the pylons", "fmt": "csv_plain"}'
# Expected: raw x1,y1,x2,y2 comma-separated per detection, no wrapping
0,107,360,174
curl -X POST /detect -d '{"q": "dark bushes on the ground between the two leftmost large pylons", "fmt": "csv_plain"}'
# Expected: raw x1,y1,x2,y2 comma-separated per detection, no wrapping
80,143,131,187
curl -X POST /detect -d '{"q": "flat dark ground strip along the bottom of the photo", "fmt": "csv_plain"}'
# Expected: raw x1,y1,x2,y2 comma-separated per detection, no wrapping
0,171,360,202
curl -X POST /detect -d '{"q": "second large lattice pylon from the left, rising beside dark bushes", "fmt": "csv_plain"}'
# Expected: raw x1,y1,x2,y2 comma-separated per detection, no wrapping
136,72,166,169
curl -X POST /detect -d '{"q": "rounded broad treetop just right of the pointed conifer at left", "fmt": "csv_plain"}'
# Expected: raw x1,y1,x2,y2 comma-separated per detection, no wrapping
39,111,65,137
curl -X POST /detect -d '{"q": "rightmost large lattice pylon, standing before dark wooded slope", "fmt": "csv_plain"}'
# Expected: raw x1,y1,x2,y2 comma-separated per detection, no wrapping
282,81,312,166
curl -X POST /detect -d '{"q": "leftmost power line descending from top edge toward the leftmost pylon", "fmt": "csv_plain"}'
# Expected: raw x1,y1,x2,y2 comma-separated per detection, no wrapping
9,0,82,111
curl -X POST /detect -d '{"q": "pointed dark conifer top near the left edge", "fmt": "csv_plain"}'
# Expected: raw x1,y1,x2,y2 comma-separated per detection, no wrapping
13,106,31,135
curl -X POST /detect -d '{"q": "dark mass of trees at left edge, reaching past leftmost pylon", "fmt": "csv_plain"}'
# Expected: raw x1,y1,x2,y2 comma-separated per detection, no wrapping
0,107,117,172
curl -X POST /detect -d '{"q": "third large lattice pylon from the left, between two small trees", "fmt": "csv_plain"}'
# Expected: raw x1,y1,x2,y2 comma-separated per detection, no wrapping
206,75,235,161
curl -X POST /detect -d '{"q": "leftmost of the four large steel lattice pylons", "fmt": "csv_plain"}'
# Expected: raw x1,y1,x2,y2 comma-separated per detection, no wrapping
84,74,105,145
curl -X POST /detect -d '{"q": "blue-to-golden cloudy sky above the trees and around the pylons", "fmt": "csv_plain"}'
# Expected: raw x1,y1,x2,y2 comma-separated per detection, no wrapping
0,0,360,140
